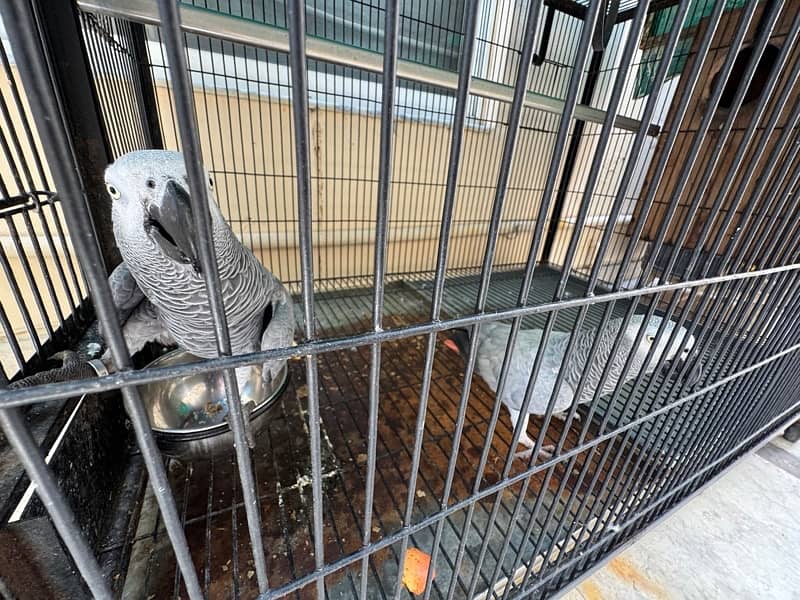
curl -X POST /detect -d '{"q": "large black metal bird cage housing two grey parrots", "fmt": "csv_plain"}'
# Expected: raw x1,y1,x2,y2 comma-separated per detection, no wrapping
0,0,800,600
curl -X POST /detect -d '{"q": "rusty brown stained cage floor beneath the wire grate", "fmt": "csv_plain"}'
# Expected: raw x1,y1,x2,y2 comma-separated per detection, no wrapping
126,284,656,598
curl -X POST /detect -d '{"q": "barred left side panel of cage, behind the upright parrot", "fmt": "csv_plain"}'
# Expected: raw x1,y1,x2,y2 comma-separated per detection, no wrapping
0,29,86,378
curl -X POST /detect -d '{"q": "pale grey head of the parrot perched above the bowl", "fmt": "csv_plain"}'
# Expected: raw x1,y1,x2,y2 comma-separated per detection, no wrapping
105,150,226,274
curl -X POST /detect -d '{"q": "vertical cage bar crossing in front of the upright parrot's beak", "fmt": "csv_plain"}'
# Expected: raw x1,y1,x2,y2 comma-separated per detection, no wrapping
154,0,269,593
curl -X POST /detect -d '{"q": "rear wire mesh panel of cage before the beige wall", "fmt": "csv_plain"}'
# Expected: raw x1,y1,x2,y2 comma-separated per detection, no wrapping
83,2,668,289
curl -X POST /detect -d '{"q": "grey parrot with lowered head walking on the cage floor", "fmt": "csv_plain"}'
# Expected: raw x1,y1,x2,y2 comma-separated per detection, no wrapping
445,315,694,456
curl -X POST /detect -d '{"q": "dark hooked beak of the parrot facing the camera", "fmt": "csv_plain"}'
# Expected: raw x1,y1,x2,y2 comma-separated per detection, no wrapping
146,180,201,274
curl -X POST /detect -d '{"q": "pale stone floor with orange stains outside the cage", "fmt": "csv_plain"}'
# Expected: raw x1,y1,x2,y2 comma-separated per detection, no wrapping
563,426,800,600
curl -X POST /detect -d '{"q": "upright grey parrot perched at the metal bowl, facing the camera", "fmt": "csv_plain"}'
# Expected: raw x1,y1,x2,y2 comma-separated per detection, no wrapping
10,150,294,412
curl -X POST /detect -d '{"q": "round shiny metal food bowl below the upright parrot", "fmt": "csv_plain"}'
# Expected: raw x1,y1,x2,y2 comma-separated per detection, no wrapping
141,349,288,461
